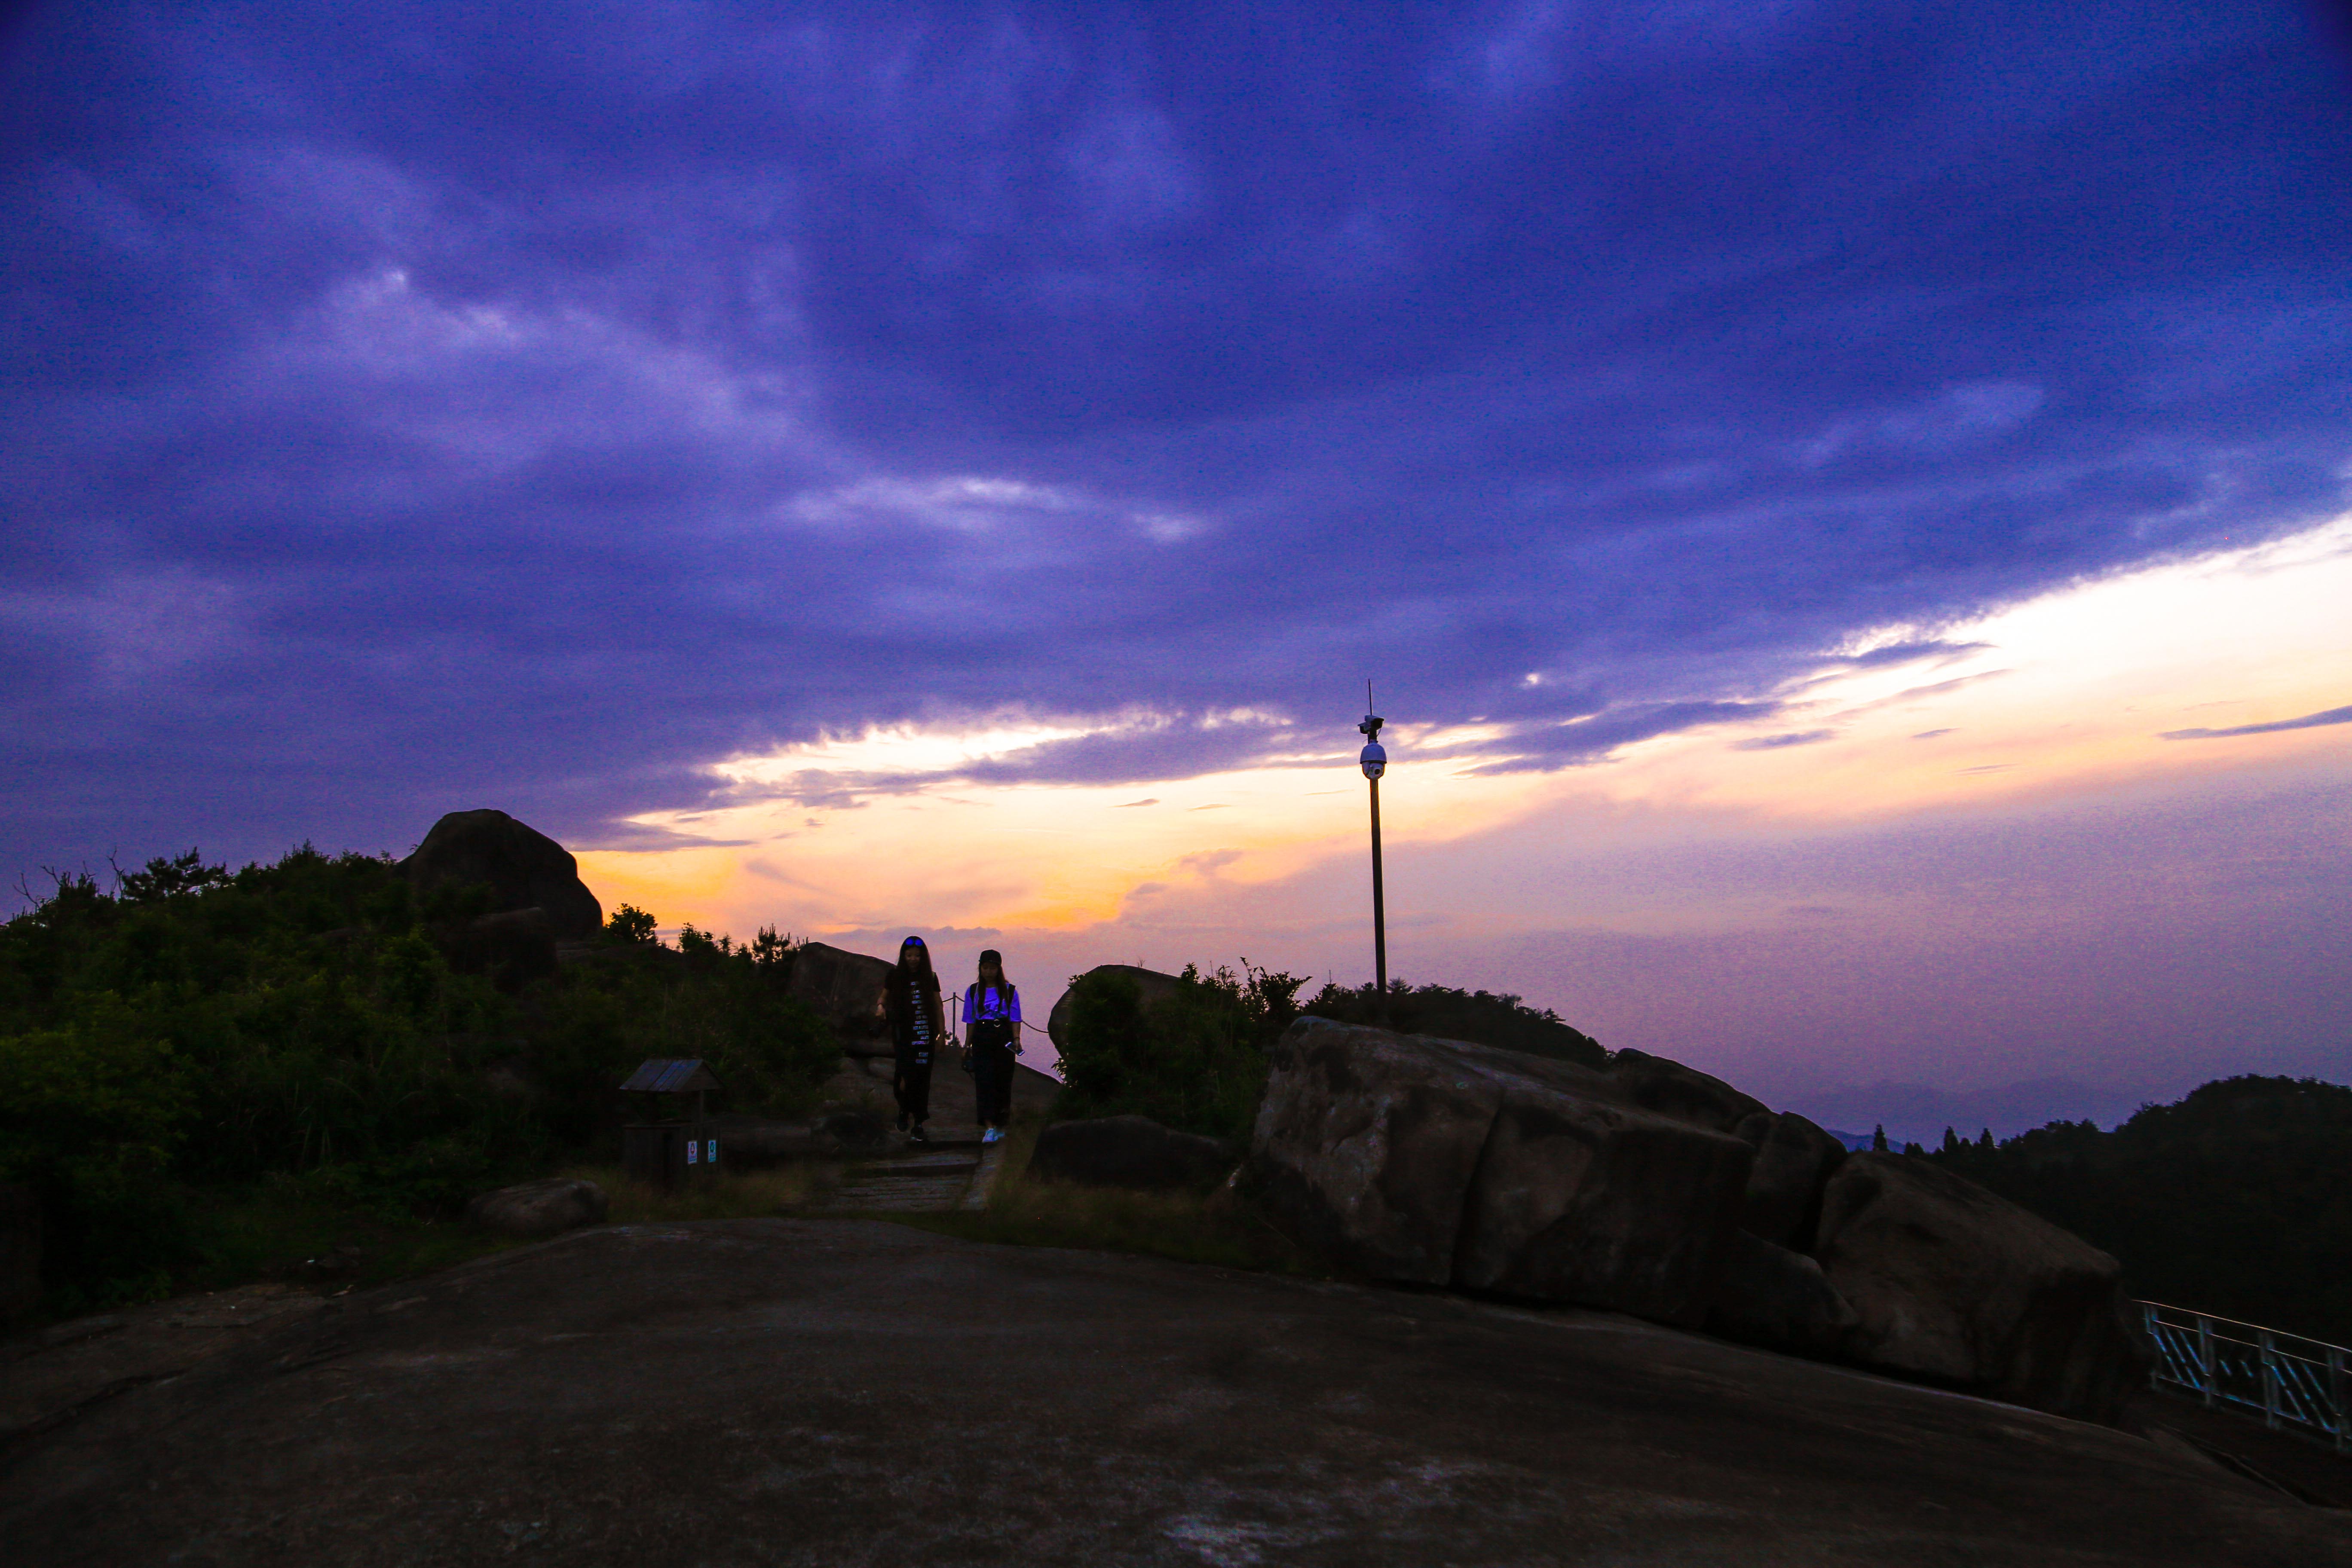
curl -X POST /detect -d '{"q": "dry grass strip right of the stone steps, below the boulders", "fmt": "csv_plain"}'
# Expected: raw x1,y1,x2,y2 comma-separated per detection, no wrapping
880,1117,1334,1279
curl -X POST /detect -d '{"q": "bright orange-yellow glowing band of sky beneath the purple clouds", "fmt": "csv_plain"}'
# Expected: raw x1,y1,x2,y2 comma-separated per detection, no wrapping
581,520,2352,950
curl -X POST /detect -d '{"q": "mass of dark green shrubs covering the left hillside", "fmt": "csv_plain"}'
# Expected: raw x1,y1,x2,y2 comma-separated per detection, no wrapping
0,844,837,1305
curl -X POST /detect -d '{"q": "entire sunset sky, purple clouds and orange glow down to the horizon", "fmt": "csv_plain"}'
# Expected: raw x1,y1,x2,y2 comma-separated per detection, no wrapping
0,0,2352,1131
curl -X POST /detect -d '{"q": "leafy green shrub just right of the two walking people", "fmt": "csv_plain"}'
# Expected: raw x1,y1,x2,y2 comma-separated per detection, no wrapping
1056,959,1305,1140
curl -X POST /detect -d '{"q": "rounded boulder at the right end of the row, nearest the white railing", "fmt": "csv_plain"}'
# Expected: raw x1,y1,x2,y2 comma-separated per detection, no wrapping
1813,1154,2136,1420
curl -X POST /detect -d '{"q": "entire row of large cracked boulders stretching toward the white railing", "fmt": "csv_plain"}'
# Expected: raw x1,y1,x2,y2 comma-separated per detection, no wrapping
1251,1018,2136,1420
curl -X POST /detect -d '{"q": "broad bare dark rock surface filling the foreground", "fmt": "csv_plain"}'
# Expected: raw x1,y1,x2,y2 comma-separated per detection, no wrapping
0,1220,2352,1568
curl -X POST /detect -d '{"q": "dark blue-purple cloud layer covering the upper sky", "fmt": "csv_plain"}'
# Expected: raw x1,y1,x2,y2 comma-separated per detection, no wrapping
0,2,2352,879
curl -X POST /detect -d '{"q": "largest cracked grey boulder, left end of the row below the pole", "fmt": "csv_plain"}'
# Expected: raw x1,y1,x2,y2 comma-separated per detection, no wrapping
1251,1018,1752,1326
